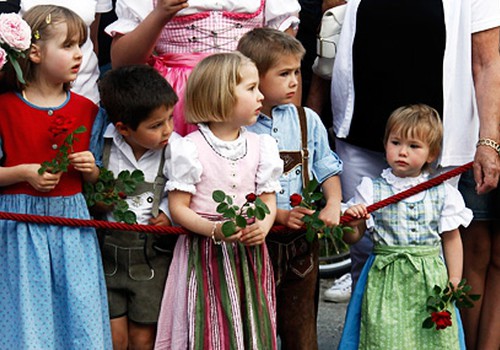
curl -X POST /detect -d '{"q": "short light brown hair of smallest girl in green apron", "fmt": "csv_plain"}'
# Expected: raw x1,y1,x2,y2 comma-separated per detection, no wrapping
384,104,443,157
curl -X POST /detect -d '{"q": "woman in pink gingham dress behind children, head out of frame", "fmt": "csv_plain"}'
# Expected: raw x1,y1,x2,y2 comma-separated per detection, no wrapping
106,0,300,135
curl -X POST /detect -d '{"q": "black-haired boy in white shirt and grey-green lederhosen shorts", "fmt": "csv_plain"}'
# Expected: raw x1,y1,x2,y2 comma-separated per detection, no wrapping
100,65,180,349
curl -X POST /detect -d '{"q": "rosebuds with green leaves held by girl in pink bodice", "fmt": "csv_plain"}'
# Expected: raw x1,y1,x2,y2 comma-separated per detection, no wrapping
212,190,270,237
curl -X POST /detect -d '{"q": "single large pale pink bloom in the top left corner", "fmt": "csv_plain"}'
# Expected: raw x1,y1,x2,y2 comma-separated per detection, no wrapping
0,13,31,52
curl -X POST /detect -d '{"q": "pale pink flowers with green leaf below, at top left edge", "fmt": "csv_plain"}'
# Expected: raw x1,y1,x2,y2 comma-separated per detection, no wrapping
0,13,31,84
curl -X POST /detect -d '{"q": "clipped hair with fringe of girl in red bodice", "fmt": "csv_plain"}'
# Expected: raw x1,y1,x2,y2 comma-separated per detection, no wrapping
20,5,87,90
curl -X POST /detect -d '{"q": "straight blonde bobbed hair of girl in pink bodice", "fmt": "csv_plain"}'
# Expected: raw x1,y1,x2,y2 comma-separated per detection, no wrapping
184,52,254,124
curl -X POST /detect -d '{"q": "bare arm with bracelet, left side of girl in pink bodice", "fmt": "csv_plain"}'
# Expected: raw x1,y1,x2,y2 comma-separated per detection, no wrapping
168,191,242,242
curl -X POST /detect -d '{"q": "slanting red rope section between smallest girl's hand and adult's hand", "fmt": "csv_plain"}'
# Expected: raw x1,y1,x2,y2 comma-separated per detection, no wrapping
340,162,473,224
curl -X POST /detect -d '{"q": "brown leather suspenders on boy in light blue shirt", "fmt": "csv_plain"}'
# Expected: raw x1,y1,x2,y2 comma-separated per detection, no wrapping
280,106,309,188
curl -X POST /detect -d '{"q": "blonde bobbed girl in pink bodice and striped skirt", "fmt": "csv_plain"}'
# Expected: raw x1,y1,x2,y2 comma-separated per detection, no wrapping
156,53,283,350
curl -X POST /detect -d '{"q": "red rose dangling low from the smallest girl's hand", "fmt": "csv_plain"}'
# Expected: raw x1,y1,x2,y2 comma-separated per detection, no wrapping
422,279,481,330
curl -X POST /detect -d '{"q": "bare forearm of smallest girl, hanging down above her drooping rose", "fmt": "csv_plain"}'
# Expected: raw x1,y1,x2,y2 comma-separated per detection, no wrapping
441,229,463,286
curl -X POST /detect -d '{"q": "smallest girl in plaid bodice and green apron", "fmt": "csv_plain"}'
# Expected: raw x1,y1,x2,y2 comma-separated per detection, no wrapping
339,105,472,350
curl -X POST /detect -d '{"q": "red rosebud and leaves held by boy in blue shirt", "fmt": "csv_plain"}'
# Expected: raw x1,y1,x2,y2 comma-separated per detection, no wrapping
290,179,353,247
